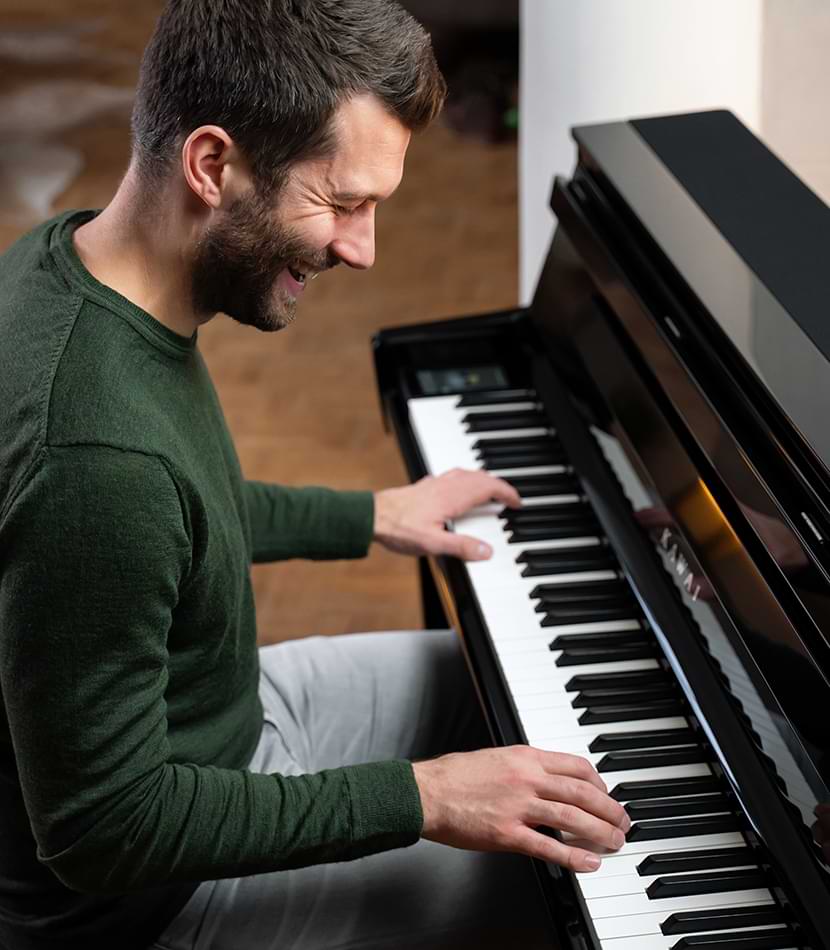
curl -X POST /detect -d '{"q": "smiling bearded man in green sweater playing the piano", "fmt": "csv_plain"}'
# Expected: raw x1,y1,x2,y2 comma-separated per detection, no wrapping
0,0,627,950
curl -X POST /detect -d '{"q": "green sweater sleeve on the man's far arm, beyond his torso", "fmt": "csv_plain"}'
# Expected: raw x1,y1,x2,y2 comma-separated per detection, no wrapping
245,481,375,563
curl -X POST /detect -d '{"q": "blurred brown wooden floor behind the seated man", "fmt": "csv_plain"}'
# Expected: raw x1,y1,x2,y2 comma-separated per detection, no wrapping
0,0,518,642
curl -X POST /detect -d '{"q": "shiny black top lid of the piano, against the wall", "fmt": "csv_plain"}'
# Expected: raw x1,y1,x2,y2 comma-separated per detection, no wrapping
573,110,830,494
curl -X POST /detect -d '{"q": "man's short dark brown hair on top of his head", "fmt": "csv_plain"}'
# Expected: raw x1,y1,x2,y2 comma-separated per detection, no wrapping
132,0,446,193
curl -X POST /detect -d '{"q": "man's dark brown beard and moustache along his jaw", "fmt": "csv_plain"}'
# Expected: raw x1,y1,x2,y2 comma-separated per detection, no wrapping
191,190,338,332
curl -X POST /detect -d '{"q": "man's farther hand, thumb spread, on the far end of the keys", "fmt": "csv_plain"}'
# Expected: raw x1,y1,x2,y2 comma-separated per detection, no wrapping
374,468,521,561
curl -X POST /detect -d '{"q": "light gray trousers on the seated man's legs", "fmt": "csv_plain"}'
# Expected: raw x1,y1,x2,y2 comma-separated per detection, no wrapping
154,630,552,950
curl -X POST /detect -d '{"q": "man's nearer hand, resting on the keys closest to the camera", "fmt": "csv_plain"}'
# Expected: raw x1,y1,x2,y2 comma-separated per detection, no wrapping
413,745,631,871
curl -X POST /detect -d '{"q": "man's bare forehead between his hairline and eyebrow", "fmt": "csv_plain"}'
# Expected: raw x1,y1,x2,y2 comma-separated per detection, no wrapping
295,95,410,200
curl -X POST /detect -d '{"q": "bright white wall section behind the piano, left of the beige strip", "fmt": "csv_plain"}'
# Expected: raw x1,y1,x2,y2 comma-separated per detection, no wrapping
519,0,763,302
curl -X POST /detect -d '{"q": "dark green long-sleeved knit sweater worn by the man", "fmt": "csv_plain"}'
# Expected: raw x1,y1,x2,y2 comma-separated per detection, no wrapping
0,212,423,950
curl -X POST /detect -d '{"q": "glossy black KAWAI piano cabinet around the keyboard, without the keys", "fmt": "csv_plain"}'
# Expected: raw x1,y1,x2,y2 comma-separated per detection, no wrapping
374,112,830,950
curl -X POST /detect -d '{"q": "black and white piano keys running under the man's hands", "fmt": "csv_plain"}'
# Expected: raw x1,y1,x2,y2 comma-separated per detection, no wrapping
408,390,798,950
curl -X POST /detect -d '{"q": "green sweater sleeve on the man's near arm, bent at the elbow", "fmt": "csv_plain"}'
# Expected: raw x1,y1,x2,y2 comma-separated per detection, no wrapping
0,447,423,894
